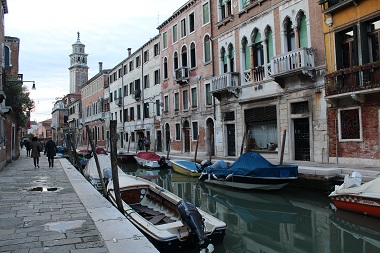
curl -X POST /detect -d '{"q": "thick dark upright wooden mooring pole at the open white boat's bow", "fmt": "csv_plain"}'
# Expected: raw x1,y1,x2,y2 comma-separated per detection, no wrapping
110,120,124,213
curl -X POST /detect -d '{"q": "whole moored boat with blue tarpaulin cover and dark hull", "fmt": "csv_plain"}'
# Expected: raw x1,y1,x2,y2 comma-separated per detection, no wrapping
199,152,298,190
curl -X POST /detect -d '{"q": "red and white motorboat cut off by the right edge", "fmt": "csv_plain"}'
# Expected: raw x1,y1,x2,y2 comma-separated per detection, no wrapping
329,171,380,218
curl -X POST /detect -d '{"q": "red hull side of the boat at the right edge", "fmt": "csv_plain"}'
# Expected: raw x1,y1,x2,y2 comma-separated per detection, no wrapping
331,195,380,218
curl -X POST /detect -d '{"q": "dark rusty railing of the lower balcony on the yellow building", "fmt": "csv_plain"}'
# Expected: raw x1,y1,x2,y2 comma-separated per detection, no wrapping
325,61,380,96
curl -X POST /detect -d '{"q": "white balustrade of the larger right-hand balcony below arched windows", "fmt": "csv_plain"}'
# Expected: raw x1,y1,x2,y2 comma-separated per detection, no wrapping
271,47,314,76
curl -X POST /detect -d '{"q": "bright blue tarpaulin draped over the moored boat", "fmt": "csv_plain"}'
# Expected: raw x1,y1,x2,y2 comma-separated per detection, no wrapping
203,152,298,178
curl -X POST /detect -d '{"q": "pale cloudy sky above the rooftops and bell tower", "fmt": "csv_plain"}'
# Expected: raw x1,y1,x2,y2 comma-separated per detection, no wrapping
4,0,187,121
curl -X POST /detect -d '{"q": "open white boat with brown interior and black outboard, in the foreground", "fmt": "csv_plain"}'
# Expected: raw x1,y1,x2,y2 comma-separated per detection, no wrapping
107,175,227,252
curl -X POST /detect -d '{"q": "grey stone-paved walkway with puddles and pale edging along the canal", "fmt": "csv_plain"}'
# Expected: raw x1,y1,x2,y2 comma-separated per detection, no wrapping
0,150,158,253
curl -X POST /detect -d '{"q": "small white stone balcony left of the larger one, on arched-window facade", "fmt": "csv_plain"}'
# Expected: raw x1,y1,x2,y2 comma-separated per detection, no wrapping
211,72,240,100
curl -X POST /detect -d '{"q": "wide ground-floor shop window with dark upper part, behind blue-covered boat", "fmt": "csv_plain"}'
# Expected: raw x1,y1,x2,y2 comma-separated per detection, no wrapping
244,106,278,150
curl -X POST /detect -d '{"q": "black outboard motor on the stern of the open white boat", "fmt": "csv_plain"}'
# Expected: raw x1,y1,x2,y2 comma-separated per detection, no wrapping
177,200,214,252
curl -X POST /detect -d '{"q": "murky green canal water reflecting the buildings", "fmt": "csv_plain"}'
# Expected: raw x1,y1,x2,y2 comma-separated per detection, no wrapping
119,163,380,253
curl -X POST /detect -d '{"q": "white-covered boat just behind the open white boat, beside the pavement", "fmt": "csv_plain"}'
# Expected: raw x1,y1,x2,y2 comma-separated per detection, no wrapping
83,154,125,191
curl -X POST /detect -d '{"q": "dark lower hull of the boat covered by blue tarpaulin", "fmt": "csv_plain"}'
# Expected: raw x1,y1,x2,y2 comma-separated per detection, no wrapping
199,173,297,190
